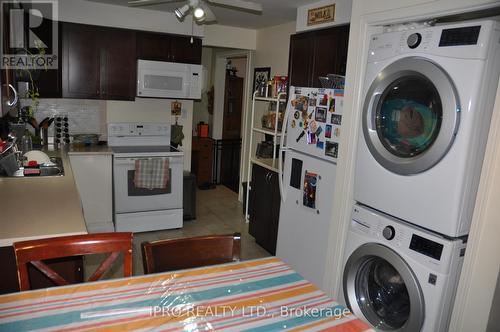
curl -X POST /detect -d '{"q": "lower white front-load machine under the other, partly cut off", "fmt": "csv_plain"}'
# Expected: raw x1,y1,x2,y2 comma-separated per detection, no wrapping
340,205,466,332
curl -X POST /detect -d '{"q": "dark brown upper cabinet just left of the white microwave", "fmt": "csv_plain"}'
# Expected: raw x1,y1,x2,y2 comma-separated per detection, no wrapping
62,23,137,100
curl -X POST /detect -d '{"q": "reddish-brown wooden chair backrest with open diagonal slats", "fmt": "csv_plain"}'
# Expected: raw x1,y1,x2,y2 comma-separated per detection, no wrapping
14,232,133,291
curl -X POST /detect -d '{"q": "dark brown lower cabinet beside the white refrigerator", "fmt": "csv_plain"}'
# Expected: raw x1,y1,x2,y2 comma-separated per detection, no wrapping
248,164,281,255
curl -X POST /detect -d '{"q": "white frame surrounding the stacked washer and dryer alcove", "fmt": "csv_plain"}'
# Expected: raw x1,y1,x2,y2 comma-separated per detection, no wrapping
323,0,500,332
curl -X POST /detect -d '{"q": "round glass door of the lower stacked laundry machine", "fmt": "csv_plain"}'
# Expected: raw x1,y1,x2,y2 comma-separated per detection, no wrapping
344,243,425,331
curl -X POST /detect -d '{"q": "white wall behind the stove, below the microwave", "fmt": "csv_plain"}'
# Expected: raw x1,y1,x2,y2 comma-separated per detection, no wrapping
106,98,193,171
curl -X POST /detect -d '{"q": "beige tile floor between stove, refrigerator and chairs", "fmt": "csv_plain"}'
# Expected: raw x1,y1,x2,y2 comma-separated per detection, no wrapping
85,186,270,278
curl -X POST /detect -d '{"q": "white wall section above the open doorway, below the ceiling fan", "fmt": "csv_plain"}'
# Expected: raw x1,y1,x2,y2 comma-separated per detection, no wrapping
203,24,257,50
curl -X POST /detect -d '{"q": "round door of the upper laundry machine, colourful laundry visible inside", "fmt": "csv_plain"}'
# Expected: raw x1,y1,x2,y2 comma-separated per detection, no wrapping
363,57,460,175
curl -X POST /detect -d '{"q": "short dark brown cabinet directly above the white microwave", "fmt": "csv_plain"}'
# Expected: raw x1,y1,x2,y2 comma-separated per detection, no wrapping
137,32,201,64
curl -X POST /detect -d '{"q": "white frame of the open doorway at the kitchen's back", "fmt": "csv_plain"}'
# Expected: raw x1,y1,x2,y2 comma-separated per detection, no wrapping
212,50,255,202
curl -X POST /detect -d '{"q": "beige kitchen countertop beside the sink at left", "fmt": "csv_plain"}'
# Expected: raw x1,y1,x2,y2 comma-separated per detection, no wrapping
0,146,87,247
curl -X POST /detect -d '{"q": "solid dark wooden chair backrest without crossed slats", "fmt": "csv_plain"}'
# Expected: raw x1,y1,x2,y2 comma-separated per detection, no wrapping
142,233,241,274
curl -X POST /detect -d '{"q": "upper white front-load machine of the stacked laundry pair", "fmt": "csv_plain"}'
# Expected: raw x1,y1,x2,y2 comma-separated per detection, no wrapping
354,21,500,237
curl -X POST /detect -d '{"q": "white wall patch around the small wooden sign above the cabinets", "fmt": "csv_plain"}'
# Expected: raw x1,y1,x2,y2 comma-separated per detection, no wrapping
296,0,352,32
